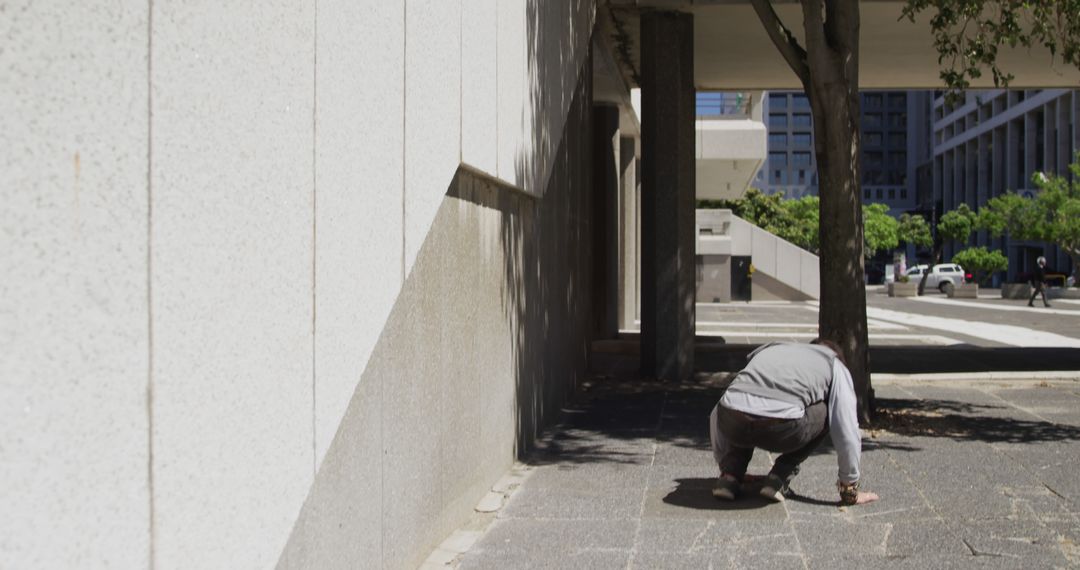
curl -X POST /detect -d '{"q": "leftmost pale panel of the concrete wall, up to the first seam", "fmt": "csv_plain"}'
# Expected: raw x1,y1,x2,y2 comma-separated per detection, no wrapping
0,2,150,568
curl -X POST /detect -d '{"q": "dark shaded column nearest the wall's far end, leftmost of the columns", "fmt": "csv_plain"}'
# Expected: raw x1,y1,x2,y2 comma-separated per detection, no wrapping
593,105,621,338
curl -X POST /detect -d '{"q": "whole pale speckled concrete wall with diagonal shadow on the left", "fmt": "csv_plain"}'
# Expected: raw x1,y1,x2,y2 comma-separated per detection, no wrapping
0,0,594,569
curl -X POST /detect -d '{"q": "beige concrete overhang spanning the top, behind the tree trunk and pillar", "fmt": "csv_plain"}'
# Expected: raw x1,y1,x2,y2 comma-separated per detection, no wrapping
599,0,1080,90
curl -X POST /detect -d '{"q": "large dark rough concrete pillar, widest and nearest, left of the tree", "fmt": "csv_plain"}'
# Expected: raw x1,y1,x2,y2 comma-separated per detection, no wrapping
642,11,696,381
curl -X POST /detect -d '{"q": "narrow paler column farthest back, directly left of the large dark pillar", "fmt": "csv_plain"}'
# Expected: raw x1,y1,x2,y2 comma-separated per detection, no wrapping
619,137,638,328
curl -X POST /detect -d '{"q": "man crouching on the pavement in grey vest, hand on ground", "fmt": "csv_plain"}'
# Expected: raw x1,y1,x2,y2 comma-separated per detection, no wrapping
708,339,878,505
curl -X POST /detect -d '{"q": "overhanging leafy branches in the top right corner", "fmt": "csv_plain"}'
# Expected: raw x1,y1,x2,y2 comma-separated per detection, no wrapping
903,0,1080,105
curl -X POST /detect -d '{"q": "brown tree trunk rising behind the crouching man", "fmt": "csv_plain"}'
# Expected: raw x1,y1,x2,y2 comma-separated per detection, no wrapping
802,0,874,422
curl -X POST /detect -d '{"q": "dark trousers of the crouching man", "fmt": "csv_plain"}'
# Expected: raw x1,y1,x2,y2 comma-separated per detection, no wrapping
708,402,828,481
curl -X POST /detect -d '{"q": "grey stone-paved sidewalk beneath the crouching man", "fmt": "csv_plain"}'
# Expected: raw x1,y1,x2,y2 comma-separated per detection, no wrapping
459,380,1080,569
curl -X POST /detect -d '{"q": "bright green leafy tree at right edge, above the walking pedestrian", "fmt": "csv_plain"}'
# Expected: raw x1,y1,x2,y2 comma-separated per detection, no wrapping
978,153,1080,282
